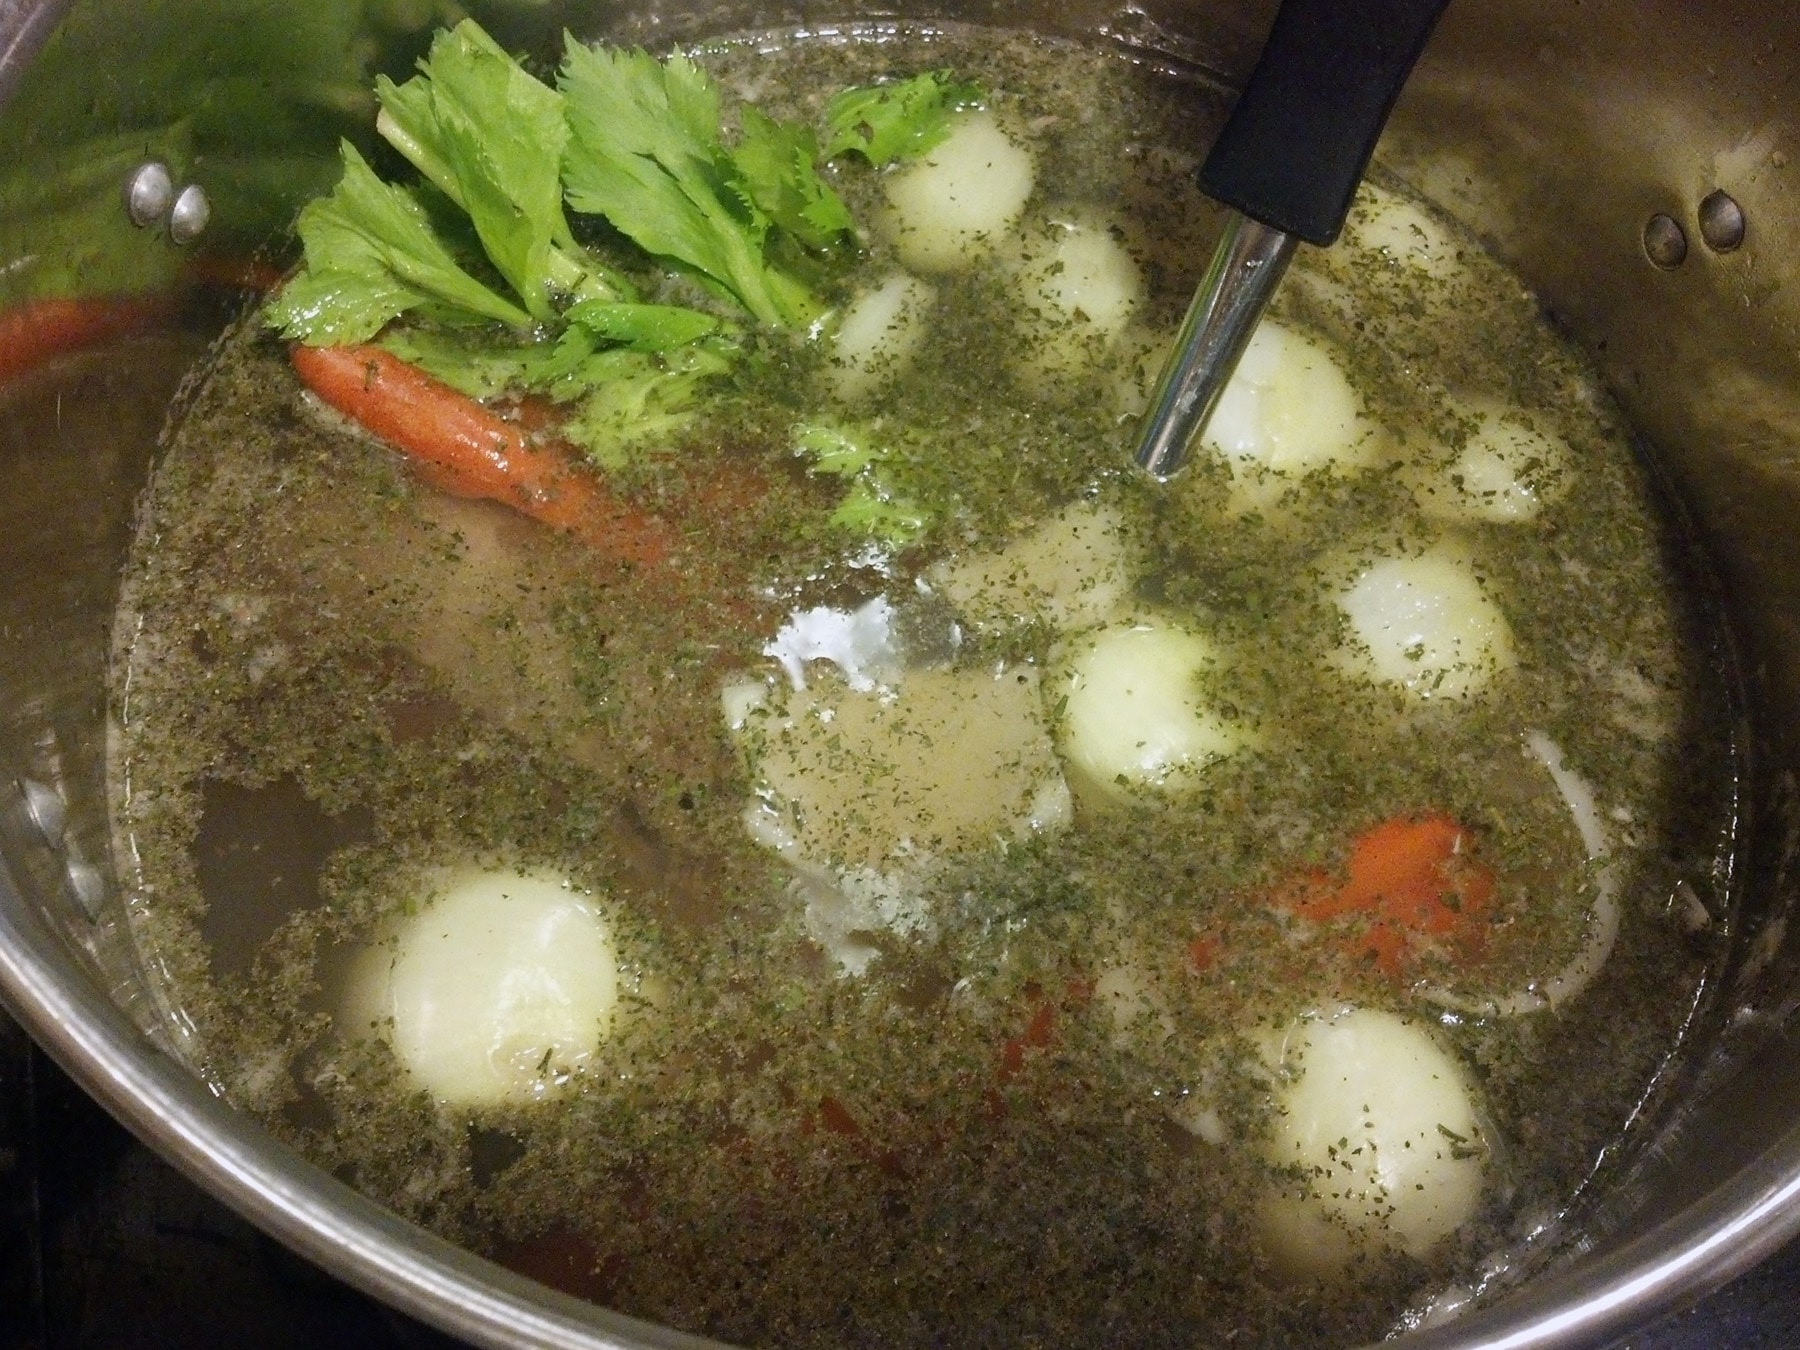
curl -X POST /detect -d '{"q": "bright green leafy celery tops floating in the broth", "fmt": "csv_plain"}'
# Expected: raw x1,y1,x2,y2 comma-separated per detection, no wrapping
265,20,981,545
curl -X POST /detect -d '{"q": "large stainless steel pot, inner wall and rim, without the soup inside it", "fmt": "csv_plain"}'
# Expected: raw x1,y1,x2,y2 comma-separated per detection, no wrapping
0,0,1800,1350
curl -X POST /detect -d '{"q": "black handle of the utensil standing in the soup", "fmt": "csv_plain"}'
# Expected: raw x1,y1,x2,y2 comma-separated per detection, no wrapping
1201,0,1449,245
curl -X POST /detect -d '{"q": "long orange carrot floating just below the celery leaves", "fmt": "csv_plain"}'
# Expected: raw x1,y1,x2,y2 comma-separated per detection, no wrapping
290,344,675,567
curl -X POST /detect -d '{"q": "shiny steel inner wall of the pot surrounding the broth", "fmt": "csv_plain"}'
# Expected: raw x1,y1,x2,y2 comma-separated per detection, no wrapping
0,0,1800,1346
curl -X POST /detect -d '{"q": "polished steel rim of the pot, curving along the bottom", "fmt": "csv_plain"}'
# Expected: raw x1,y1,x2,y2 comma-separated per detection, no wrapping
0,0,1800,1350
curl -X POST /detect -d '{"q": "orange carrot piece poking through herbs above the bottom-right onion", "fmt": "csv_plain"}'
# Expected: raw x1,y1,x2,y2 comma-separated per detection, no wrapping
1276,812,1494,977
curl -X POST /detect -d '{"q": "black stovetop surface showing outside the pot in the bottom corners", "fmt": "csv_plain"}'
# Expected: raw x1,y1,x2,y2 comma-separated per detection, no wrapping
0,1015,1800,1350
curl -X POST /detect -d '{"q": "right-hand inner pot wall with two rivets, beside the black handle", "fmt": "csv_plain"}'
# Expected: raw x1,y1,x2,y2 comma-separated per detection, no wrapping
1384,4,1800,1213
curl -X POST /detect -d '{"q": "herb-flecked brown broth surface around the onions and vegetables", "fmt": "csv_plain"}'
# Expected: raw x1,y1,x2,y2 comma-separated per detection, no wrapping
113,31,1733,1346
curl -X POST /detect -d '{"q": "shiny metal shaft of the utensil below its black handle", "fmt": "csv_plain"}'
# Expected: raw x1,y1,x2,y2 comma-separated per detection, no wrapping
1132,211,1298,479
